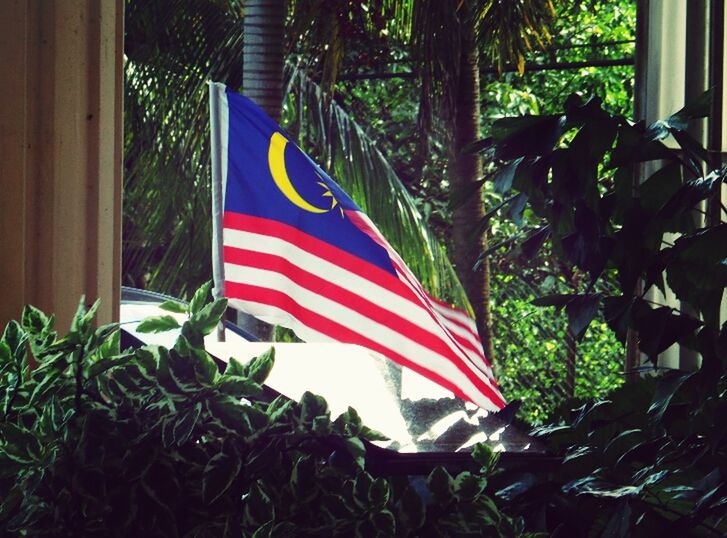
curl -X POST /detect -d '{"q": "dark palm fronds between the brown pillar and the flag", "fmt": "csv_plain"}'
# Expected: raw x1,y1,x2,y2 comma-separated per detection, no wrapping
123,0,243,297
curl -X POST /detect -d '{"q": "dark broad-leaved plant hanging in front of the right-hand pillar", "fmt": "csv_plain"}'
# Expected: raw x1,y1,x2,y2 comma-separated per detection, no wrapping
474,92,727,369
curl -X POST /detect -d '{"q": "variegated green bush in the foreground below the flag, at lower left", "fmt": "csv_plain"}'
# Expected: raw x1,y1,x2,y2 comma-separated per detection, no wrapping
0,286,536,537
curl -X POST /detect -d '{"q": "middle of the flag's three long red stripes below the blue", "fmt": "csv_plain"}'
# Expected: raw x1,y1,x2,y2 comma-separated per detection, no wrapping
224,246,492,377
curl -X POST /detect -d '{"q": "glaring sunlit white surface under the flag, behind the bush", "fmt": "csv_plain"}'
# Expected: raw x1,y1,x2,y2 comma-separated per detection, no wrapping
121,301,539,452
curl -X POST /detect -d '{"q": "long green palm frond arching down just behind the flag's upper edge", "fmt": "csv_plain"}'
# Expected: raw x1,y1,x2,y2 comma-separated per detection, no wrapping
284,67,470,310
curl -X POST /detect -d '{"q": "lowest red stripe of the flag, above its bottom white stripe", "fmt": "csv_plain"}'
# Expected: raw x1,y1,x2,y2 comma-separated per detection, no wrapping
225,281,505,408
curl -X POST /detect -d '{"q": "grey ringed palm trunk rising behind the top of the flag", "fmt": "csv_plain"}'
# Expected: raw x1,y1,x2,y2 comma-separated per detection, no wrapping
237,0,285,341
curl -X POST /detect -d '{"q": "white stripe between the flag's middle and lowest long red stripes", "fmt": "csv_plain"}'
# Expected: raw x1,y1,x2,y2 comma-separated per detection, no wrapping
225,263,504,400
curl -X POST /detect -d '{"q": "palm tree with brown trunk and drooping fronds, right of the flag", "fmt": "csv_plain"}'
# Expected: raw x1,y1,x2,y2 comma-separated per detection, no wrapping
411,0,554,361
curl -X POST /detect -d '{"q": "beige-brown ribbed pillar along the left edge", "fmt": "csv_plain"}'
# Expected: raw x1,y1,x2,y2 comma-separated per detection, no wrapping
0,0,123,331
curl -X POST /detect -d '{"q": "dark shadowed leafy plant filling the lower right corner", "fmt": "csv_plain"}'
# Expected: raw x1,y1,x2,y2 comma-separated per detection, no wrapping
498,371,727,536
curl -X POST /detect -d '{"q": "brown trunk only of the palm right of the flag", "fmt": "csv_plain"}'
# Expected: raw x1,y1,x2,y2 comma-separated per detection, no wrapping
448,16,494,361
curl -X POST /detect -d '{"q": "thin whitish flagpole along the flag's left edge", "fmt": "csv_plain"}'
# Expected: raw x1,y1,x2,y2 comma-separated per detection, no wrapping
208,81,225,342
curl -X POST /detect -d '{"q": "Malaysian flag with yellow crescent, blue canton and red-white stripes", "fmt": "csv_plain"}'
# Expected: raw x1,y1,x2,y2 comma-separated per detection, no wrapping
210,84,505,410
